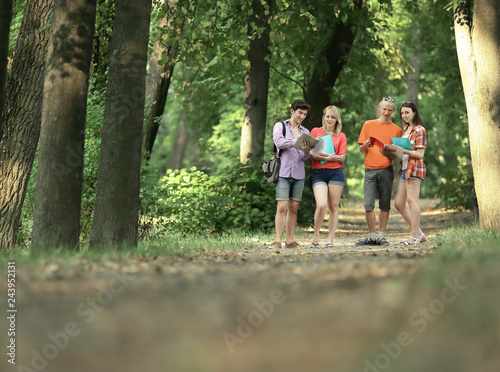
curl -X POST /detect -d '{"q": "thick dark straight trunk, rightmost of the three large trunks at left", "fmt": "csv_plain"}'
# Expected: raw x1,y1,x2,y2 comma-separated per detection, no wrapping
90,0,151,248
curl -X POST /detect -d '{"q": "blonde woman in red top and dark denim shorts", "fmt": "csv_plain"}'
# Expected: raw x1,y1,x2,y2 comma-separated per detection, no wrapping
310,106,347,248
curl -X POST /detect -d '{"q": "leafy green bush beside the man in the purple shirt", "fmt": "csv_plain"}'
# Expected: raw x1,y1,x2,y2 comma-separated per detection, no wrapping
157,162,276,234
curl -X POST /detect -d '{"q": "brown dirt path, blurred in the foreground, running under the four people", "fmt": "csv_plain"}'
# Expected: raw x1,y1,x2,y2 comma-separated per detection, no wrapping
0,202,470,372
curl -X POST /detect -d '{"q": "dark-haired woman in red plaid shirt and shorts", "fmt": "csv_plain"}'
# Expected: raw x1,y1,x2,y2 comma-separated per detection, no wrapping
394,101,427,245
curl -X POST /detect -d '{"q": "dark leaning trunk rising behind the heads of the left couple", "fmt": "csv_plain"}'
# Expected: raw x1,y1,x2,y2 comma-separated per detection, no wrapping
303,0,363,130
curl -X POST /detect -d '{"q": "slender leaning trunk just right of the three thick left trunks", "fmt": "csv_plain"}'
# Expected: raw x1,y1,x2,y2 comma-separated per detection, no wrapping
142,0,183,160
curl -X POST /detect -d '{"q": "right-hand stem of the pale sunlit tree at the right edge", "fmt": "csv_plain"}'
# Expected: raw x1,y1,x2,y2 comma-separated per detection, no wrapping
468,0,500,231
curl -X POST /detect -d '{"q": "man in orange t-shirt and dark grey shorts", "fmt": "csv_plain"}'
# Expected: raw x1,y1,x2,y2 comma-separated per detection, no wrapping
356,97,403,245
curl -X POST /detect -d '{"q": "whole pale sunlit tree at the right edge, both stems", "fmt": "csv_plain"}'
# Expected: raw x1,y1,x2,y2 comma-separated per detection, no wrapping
454,0,500,230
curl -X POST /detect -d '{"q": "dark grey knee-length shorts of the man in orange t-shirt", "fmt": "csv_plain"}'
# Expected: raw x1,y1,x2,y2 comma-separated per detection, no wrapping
363,165,394,211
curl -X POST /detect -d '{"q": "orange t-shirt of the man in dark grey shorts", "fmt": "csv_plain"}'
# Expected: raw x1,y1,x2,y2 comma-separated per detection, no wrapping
358,119,403,169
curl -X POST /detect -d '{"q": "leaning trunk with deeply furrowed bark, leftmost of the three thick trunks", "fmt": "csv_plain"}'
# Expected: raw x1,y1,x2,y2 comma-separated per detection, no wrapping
0,0,52,250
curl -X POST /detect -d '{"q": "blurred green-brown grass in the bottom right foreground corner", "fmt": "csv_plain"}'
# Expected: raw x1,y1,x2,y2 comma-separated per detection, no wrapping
356,226,500,372
